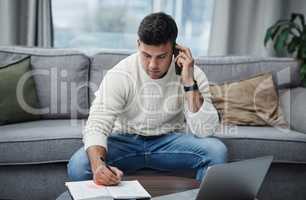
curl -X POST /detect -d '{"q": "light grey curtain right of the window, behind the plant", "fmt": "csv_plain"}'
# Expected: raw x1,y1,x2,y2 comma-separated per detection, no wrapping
208,0,306,56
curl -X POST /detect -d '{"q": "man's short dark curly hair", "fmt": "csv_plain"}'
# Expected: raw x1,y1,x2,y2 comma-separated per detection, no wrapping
137,12,177,45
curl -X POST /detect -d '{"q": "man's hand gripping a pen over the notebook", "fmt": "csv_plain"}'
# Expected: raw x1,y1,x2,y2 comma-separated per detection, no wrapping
93,163,123,185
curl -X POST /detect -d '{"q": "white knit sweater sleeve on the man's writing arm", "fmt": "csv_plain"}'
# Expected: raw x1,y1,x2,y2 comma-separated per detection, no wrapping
83,70,128,149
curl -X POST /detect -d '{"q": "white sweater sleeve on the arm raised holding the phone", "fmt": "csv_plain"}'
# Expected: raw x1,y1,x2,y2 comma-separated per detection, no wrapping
184,66,220,137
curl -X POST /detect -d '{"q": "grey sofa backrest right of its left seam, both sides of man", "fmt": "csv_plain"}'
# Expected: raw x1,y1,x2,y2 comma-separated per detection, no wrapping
89,51,301,103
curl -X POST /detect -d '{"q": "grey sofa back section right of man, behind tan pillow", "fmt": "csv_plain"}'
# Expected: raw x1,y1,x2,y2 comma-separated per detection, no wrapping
195,56,301,88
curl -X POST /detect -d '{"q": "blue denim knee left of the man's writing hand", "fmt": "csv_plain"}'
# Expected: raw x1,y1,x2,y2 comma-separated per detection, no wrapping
67,147,92,181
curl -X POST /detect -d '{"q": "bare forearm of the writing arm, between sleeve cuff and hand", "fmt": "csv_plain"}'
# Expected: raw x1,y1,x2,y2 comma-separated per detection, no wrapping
86,145,106,170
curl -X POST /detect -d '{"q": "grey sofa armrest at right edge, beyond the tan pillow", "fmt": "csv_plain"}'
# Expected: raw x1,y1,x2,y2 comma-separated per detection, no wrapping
290,87,306,133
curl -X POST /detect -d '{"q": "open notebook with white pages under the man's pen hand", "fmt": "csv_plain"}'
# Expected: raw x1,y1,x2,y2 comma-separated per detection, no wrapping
65,180,151,200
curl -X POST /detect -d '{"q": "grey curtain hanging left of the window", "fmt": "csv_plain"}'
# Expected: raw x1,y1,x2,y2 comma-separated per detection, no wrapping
0,0,53,47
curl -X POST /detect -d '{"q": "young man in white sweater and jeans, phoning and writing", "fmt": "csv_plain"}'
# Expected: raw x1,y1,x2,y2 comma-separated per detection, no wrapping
68,13,227,185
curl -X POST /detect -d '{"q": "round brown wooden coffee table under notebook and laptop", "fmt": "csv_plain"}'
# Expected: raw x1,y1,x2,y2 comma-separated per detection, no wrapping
56,175,200,200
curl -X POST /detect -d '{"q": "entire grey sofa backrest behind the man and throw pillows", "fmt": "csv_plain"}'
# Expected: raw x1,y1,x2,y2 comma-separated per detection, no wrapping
0,47,301,119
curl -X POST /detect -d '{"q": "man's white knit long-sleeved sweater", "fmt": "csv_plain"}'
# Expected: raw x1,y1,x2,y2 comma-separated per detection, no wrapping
83,53,219,149
